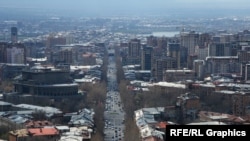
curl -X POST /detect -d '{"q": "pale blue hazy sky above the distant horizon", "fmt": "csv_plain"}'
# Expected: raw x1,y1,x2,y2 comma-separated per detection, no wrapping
0,0,250,16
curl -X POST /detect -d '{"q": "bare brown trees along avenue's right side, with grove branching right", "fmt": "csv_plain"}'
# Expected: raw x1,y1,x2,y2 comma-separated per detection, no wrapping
115,47,189,141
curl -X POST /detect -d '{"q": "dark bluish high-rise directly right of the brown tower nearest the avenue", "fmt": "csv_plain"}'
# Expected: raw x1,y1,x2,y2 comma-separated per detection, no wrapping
141,45,153,70
